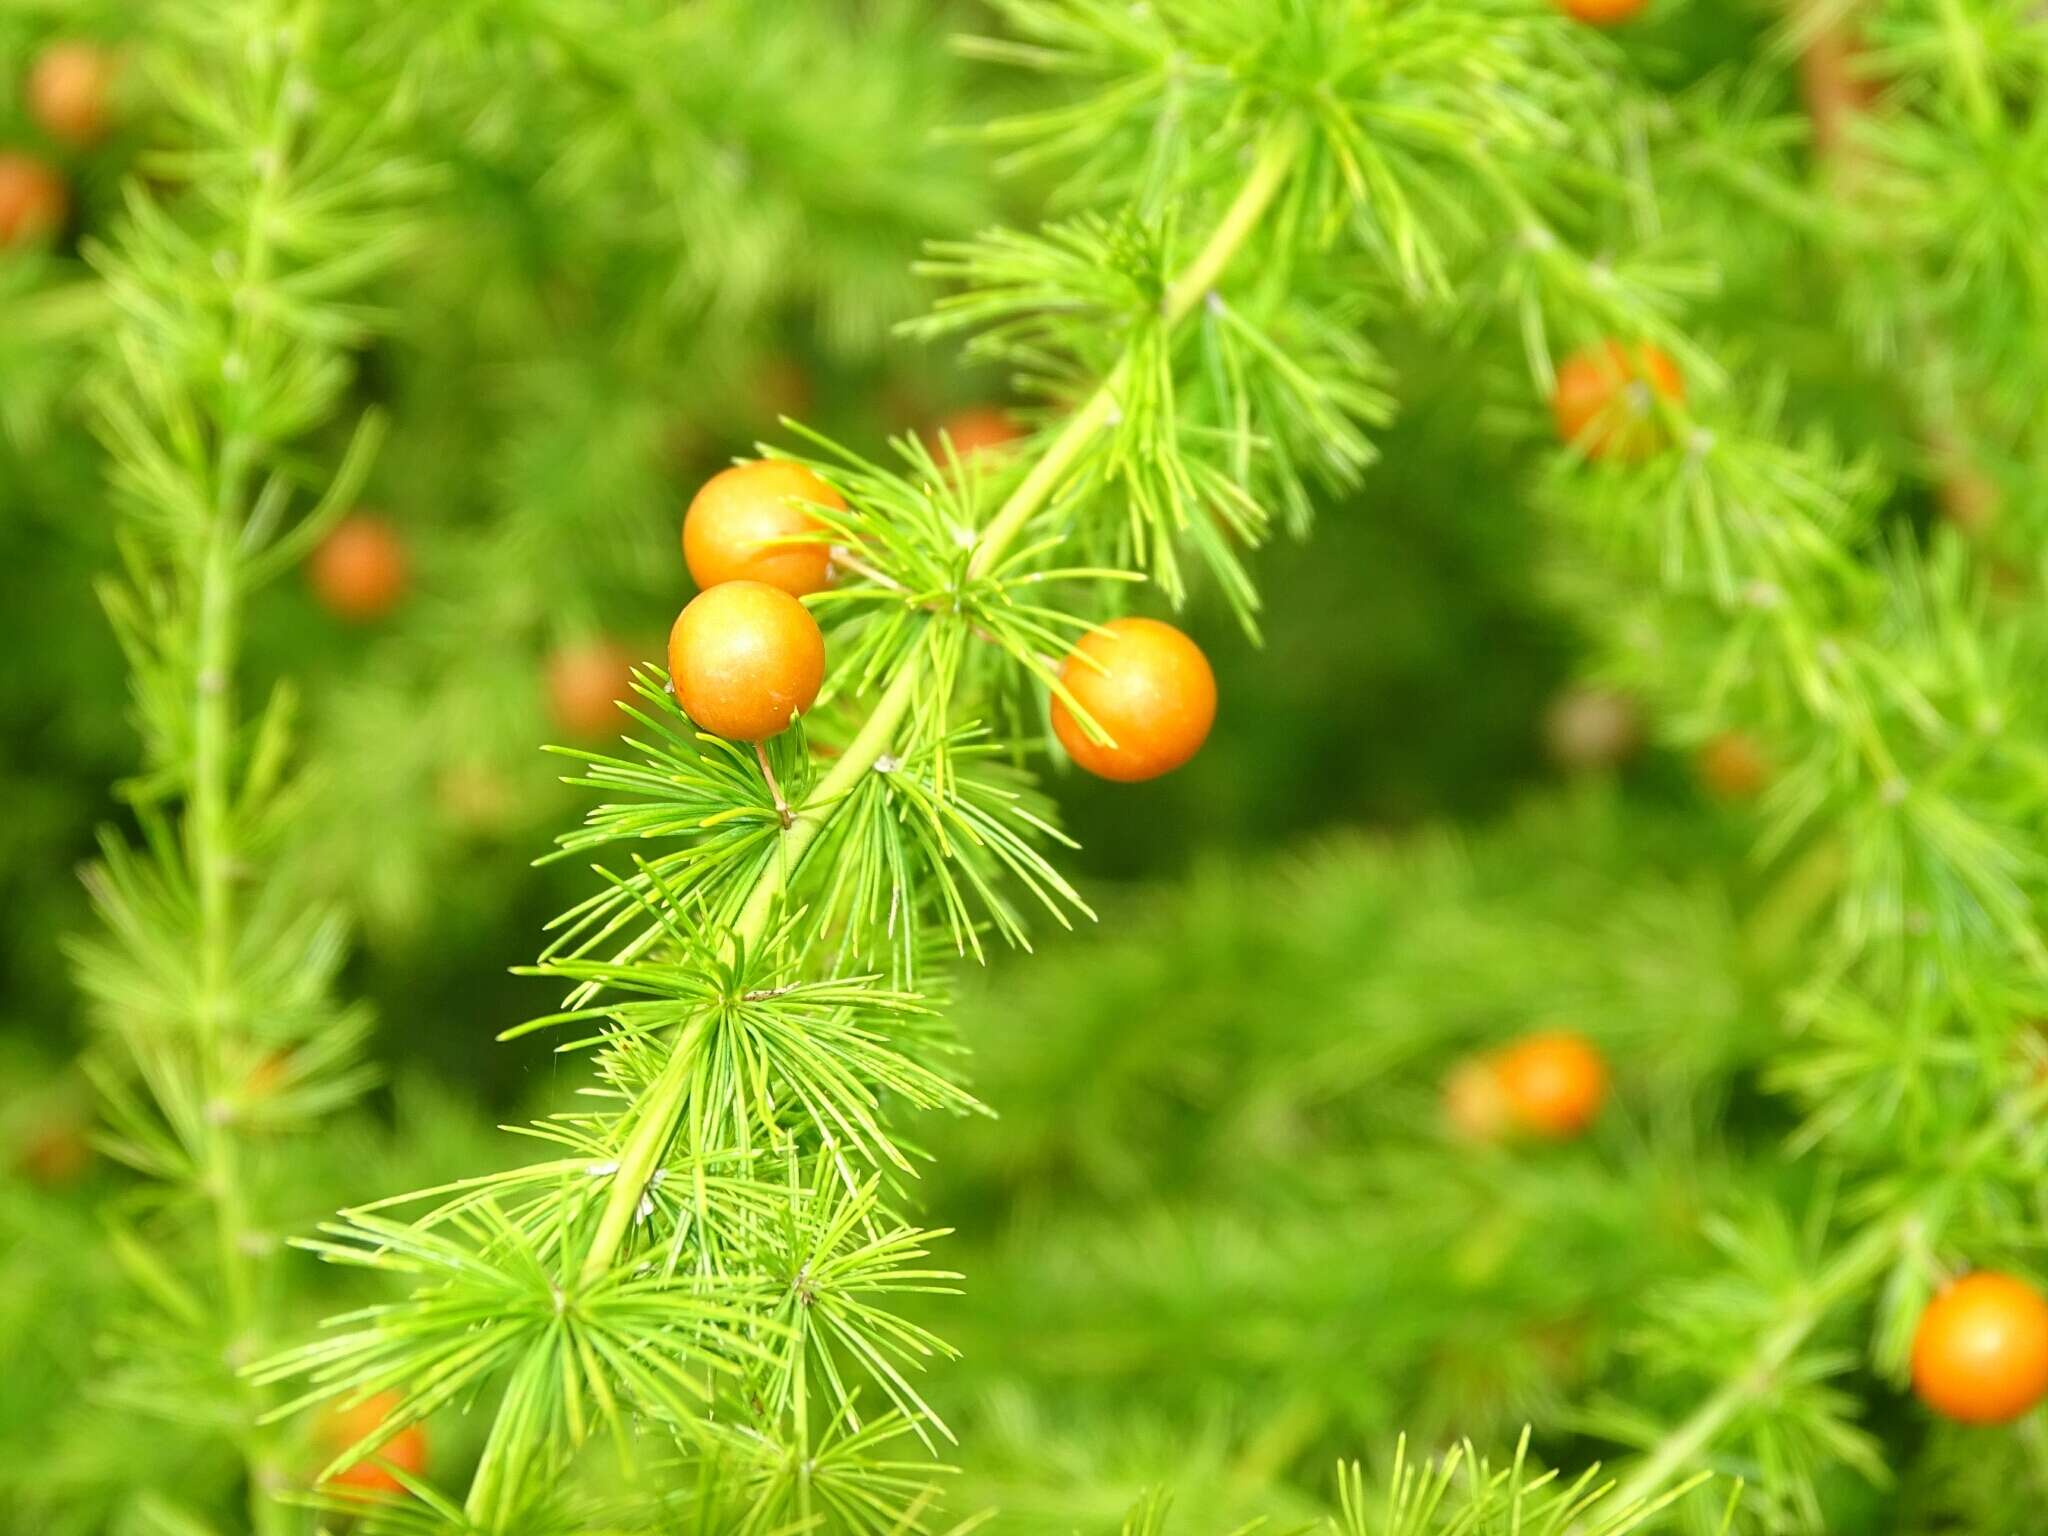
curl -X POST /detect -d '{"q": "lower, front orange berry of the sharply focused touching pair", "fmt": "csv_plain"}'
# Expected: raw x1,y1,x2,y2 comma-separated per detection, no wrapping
668,582,825,741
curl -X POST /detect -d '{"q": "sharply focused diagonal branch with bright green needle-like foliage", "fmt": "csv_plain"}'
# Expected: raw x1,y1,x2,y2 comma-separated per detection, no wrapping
256,6,1638,1532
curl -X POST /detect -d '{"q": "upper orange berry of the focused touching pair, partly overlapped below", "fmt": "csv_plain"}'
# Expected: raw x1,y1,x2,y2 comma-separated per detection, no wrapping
682,459,846,598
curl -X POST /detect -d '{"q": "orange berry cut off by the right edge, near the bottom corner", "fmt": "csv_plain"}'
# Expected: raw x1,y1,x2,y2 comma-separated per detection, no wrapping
1913,1270,2048,1423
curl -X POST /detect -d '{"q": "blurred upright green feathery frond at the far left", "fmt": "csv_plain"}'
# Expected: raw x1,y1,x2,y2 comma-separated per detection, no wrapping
58,4,426,1530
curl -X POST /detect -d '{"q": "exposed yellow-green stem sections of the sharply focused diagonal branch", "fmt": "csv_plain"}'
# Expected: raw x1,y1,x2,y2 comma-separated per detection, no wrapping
582,123,1303,1284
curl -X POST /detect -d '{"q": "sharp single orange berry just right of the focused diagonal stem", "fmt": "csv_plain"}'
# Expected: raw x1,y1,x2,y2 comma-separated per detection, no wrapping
1053,618,1217,784
